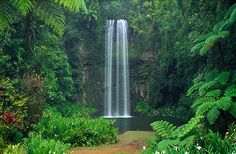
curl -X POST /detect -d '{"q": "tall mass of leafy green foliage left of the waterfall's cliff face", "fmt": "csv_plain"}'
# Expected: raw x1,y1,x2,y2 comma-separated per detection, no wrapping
34,32,73,104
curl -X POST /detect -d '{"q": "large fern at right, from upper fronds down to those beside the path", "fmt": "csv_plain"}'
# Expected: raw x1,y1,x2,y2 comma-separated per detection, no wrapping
151,71,236,150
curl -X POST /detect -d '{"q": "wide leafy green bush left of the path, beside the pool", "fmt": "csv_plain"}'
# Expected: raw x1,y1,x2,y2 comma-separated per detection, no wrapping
35,110,117,146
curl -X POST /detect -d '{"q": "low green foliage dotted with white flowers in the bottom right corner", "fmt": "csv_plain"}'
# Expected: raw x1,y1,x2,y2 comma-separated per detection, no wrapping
146,124,236,154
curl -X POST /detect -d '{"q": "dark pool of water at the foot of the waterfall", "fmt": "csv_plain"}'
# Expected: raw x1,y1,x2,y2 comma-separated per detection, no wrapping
105,116,183,133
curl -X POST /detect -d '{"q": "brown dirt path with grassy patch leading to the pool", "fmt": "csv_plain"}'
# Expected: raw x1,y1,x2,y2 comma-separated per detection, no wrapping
70,131,155,154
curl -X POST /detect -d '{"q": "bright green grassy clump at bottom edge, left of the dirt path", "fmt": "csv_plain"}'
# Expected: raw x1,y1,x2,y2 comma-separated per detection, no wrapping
24,134,69,154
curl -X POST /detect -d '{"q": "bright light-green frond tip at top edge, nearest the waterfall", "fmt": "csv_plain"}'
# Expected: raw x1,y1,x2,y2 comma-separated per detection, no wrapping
55,0,87,12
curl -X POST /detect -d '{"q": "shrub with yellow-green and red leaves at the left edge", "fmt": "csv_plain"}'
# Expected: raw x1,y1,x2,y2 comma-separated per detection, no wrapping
0,79,28,143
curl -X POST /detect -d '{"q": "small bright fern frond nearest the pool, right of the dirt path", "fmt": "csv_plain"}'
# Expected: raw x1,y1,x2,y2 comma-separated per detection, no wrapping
151,120,176,138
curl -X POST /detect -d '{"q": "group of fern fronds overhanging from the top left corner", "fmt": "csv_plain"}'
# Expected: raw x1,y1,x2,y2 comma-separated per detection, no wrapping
0,0,87,35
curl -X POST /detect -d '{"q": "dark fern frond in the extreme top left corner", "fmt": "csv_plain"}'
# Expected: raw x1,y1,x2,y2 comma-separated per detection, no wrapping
0,0,16,30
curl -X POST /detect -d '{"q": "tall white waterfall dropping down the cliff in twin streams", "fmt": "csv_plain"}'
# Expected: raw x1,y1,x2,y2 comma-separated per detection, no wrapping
104,20,130,117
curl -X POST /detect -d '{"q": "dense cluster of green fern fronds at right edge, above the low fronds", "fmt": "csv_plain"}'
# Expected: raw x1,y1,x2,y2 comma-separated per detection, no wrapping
187,71,235,124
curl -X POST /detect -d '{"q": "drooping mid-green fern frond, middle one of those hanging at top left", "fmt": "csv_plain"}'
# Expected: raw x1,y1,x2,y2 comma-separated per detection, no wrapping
34,0,65,35
